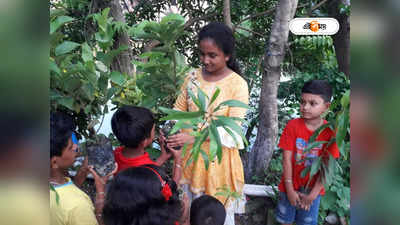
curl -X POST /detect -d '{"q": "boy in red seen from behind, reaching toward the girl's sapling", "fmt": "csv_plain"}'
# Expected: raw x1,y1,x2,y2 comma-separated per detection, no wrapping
111,106,181,183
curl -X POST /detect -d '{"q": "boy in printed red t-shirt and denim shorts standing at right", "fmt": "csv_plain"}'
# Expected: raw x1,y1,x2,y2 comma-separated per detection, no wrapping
276,80,339,225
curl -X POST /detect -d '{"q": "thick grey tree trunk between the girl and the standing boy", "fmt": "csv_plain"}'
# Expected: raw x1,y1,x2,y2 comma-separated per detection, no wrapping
245,0,297,183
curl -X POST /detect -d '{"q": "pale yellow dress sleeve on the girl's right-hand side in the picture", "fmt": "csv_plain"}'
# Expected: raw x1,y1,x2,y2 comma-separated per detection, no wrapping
228,79,249,118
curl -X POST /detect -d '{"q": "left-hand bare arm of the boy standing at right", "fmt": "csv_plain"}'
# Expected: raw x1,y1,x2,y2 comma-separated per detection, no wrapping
283,150,300,206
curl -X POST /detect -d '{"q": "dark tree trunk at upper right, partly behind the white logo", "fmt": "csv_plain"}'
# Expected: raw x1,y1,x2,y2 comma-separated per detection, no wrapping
328,0,350,77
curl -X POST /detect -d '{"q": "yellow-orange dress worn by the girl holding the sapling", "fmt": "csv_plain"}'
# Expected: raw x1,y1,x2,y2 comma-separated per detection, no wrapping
174,69,249,211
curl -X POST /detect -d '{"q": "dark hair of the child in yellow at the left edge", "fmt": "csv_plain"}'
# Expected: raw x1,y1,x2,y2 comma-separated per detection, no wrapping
50,112,75,158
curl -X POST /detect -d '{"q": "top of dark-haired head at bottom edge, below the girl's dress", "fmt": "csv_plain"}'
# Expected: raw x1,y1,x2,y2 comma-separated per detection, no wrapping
190,195,226,225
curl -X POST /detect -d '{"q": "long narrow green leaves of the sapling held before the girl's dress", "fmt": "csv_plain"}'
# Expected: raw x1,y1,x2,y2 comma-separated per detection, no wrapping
160,88,249,169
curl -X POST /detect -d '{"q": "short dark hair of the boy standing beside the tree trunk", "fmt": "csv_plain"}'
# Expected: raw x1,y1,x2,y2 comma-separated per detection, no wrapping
301,80,332,102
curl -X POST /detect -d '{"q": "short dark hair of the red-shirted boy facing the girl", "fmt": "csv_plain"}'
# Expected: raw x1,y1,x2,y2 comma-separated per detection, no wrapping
111,106,154,148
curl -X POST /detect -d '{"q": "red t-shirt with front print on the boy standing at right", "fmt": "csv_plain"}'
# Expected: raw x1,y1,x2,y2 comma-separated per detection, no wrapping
278,118,339,195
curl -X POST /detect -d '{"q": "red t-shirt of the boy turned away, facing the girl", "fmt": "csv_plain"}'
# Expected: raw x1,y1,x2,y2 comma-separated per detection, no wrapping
114,146,157,173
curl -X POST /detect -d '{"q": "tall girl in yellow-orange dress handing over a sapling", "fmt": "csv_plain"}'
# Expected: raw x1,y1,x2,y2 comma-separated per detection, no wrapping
168,22,249,224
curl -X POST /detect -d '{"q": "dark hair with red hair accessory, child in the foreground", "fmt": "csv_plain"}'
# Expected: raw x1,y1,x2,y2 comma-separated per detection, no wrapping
103,165,182,225
